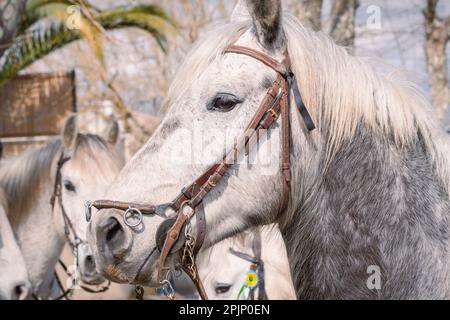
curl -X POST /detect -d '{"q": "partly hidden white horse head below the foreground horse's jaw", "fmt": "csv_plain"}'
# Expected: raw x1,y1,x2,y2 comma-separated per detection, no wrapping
197,224,296,300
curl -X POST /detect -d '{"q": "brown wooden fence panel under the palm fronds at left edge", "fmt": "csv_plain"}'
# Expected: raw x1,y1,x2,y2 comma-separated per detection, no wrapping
0,71,77,156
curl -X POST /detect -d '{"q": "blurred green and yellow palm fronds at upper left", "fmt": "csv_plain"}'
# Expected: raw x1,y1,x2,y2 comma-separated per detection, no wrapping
0,0,175,84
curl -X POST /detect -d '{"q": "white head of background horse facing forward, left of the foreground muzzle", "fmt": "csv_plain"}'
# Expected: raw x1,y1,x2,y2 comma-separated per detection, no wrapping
55,116,123,284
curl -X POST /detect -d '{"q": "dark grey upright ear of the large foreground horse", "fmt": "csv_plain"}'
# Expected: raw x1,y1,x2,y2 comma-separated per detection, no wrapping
244,0,284,49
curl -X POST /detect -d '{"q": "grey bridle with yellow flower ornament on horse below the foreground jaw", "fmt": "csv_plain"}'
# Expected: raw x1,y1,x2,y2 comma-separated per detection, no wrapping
230,232,267,300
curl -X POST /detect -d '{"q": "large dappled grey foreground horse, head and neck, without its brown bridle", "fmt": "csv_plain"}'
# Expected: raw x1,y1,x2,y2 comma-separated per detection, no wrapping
88,0,450,298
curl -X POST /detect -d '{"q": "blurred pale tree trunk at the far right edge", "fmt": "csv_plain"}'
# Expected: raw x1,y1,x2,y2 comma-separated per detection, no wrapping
423,0,450,124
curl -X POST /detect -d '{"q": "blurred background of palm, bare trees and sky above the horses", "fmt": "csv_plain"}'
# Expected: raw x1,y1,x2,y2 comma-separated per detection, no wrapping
0,0,450,159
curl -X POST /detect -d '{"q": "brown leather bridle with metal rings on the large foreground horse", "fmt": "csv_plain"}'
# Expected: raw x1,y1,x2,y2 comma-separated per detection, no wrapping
86,45,315,299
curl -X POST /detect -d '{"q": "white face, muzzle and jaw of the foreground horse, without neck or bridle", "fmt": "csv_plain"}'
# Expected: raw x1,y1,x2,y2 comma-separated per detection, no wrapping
90,1,284,284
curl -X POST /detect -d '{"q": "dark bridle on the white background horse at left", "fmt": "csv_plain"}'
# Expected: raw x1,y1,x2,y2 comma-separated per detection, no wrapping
33,152,111,300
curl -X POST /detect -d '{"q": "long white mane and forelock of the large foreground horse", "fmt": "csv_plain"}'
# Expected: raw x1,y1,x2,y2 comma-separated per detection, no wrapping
166,12,450,189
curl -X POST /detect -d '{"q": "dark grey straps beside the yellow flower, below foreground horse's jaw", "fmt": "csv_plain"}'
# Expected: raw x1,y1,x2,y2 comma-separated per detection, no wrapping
230,232,267,300
